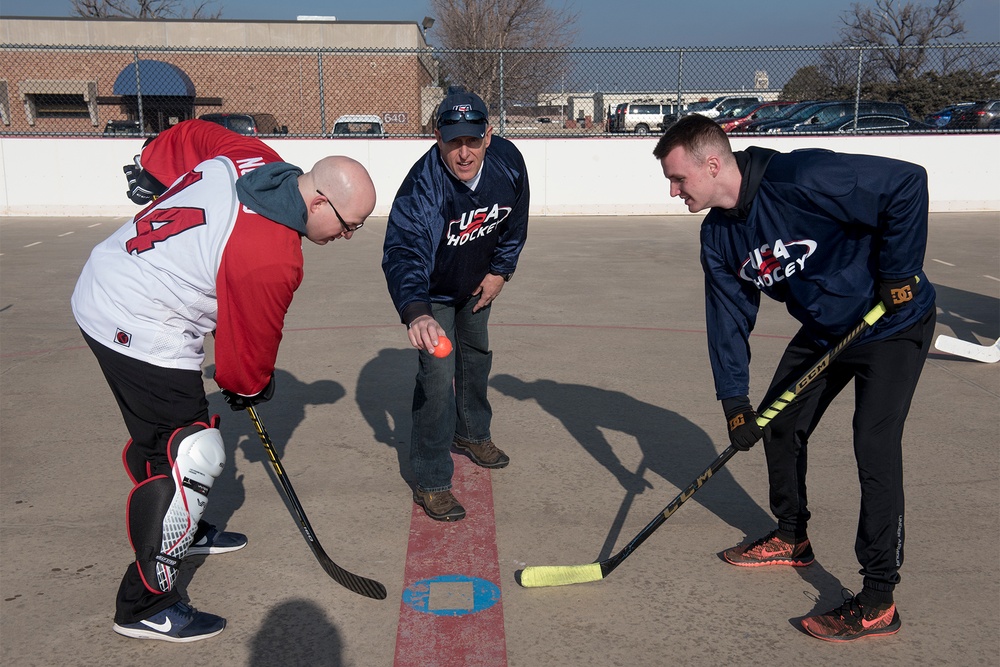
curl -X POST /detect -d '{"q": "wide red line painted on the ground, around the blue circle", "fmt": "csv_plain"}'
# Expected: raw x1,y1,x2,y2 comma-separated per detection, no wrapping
393,453,507,667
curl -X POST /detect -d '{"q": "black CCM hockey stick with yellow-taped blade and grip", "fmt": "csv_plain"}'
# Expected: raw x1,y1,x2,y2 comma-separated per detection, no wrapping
517,303,885,588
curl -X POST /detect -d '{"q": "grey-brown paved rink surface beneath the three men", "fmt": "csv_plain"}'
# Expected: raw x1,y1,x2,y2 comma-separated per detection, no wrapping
0,213,1000,667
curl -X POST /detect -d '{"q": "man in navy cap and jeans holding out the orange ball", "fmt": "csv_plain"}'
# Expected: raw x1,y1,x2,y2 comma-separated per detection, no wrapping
382,92,529,521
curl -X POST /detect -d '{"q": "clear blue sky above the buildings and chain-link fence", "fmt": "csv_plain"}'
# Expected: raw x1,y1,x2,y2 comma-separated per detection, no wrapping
0,0,1000,47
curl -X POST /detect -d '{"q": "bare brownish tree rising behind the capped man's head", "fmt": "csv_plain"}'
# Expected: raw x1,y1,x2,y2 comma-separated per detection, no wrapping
430,0,577,115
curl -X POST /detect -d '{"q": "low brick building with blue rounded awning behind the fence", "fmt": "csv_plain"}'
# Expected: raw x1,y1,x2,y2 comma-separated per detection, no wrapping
0,18,442,136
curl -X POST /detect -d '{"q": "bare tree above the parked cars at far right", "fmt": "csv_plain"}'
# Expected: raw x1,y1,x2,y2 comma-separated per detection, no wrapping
840,0,965,81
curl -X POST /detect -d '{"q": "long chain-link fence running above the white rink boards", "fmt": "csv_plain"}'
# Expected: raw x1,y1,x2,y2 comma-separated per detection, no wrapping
0,43,1000,138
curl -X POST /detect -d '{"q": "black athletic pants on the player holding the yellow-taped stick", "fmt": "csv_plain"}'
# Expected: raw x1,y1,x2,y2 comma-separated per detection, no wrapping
761,306,936,593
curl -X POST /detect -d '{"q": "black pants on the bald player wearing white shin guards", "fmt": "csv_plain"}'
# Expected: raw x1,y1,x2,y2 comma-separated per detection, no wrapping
83,334,209,624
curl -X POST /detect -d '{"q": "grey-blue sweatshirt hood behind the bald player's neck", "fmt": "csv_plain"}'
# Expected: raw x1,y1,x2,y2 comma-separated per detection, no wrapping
236,162,309,236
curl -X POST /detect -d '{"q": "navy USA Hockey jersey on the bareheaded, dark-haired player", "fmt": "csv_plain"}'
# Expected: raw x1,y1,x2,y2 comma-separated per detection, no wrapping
701,147,934,400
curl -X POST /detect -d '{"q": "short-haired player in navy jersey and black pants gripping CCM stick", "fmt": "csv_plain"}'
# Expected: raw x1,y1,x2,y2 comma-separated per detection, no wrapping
653,114,935,641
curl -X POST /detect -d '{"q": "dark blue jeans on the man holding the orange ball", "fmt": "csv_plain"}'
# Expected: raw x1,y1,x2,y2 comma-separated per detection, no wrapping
410,297,493,492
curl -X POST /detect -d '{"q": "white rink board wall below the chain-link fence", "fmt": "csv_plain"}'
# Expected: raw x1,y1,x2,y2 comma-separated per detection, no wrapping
0,133,1000,217
